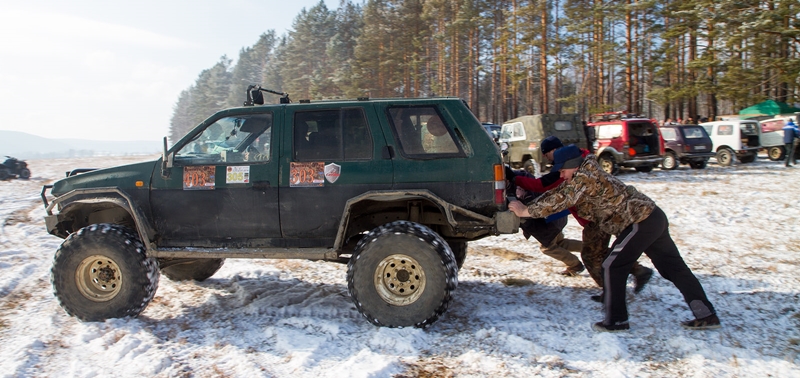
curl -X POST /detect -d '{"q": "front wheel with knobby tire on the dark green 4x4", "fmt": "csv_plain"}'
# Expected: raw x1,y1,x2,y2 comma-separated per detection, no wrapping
51,224,159,322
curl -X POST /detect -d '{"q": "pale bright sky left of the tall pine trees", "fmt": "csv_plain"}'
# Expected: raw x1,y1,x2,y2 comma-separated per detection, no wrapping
0,0,339,140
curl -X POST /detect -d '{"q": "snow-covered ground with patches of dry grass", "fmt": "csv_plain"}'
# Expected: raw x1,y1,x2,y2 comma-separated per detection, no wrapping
0,157,800,377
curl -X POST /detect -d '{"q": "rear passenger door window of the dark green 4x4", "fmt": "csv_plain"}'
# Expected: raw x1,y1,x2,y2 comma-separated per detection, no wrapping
293,108,373,161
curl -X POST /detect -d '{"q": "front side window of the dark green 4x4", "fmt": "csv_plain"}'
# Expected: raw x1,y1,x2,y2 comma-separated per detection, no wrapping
175,113,272,165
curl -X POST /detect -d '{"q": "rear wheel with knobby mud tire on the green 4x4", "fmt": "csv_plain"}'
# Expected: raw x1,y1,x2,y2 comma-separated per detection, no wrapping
347,221,458,328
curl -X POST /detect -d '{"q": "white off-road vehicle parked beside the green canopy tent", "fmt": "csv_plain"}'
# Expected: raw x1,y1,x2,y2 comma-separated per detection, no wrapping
700,120,761,166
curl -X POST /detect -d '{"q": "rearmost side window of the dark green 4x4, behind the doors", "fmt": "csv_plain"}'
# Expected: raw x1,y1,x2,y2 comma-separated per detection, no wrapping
389,106,464,157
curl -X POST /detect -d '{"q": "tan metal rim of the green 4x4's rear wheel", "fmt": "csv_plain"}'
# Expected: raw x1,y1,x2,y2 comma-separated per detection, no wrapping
374,254,426,306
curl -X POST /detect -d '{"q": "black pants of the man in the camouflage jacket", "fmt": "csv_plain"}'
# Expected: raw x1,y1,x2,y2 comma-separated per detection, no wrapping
603,206,715,324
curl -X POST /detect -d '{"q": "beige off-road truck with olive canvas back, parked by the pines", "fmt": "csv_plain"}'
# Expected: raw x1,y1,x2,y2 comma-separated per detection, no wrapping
500,114,587,176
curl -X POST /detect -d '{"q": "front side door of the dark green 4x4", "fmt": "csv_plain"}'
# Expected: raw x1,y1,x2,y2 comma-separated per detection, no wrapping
150,108,281,247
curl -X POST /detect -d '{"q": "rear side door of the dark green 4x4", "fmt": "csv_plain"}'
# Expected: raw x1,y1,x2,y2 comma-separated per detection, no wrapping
280,103,393,247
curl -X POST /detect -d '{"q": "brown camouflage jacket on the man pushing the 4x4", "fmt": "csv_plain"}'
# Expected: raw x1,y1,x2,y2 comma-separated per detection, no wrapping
528,155,656,235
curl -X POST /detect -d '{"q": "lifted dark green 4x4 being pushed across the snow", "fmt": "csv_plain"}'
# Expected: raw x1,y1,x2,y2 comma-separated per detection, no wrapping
42,86,519,327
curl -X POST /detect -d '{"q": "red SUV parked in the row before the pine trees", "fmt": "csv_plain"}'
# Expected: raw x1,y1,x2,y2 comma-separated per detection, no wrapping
588,112,664,174
